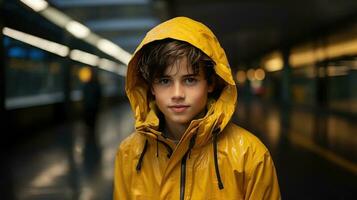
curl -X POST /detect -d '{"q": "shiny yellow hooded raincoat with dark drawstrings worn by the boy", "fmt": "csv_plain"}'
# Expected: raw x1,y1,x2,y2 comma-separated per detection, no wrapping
114,17,280,200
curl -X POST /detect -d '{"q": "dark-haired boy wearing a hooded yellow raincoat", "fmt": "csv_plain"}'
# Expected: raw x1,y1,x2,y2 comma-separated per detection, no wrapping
114,17,280,200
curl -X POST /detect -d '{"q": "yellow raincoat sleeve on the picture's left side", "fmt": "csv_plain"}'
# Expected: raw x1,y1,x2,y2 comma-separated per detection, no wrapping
113,146,131,200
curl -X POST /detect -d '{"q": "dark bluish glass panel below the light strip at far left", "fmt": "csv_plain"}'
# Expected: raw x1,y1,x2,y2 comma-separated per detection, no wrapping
3,37,63,109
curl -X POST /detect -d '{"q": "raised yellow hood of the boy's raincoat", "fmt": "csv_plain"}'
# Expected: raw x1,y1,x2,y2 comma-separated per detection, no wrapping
126,17,237,145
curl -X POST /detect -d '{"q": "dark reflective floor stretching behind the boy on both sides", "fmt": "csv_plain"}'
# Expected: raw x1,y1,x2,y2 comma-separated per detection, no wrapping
1,101,357,200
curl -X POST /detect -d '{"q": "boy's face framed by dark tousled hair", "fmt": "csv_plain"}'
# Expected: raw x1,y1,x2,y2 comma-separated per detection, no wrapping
151,58,214,126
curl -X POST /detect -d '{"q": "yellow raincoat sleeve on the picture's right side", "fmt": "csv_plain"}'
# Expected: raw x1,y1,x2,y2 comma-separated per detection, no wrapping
245,152,281,200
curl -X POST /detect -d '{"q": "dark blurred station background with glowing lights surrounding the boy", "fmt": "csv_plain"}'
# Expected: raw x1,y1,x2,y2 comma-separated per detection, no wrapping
0,0,357,200
